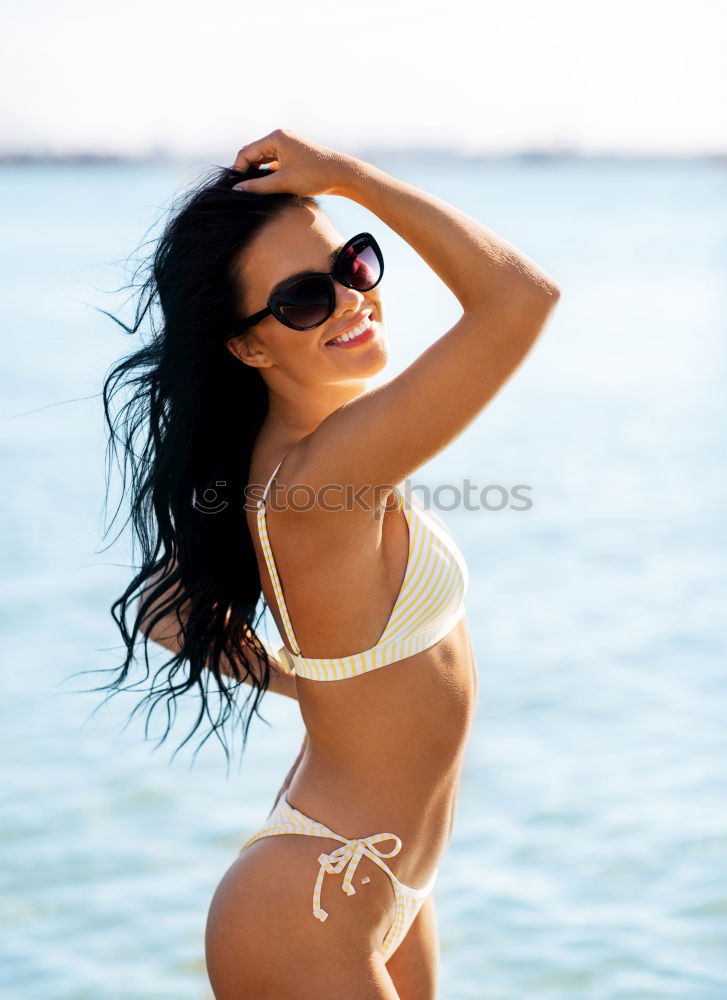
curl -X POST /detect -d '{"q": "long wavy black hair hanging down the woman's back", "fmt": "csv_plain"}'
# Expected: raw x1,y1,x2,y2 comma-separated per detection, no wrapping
94,167,320,764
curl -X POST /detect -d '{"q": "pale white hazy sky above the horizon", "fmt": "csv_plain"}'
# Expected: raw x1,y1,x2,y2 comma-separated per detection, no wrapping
0,0,727,162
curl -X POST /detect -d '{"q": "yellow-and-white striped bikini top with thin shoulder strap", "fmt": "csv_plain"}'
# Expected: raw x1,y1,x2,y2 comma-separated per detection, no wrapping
257,459,469,681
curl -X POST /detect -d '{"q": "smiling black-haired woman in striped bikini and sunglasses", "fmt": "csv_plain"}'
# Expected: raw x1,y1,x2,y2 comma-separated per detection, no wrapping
105,129,559,1000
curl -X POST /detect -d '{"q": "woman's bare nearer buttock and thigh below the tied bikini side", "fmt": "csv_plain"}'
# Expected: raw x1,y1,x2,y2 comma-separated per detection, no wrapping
205,834,399,1000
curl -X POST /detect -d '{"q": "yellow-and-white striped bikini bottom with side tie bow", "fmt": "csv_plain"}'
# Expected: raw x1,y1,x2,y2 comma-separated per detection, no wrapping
240,795,439,961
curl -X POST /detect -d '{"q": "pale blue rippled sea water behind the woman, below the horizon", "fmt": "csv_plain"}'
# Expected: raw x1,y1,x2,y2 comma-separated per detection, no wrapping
0,157,727,1000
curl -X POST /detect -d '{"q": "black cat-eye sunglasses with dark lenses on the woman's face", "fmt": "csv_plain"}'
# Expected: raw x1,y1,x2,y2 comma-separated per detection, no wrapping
232,233,384,336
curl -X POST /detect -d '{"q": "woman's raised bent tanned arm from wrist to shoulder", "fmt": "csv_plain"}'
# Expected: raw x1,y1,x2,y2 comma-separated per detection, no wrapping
282,149,560,500
